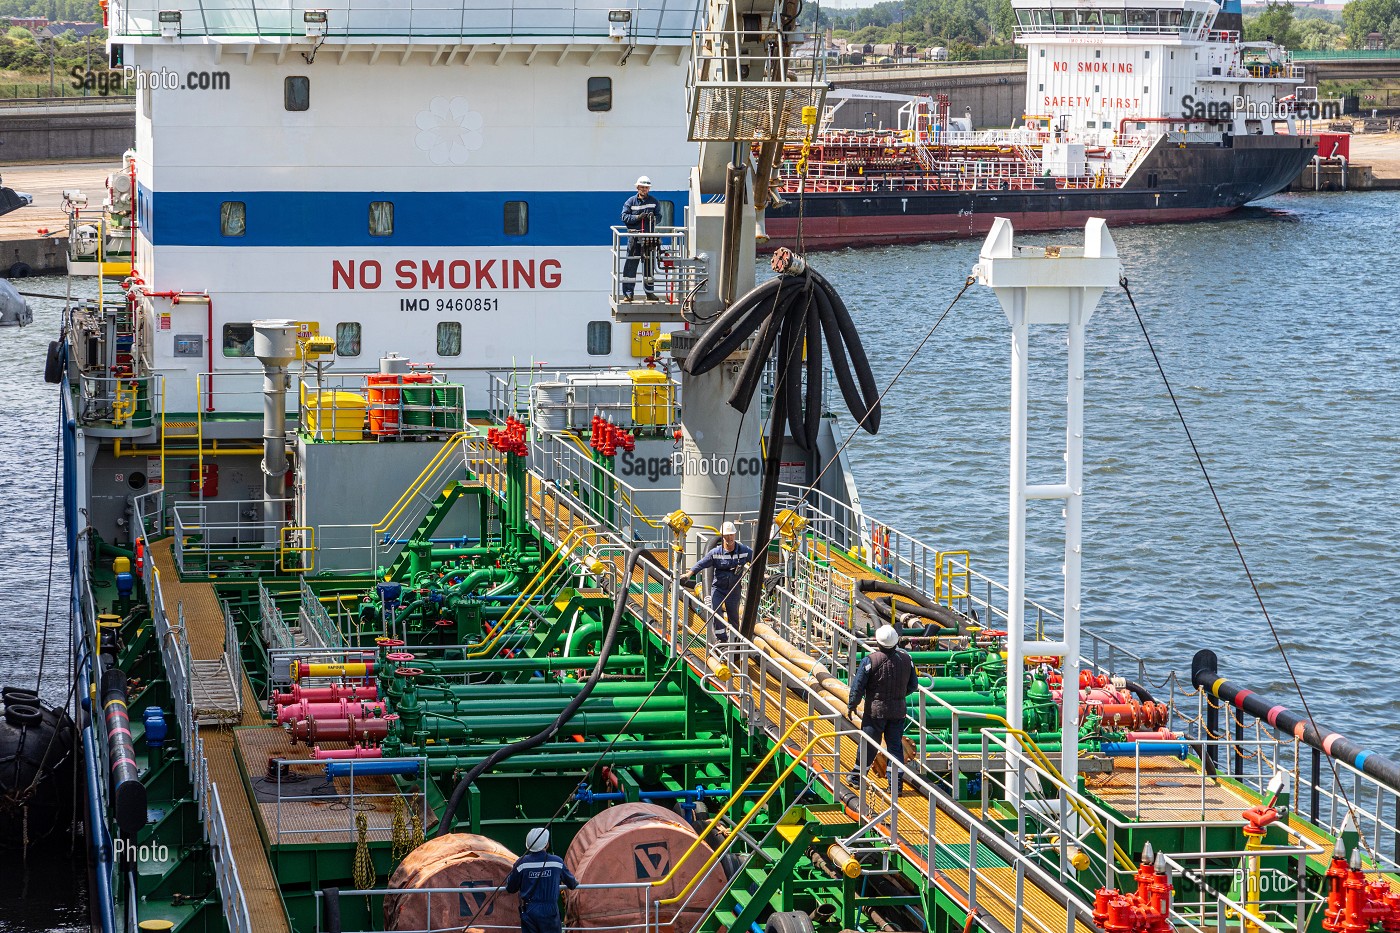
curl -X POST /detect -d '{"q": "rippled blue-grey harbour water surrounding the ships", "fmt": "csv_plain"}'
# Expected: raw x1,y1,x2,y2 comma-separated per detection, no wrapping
0,192,1400,933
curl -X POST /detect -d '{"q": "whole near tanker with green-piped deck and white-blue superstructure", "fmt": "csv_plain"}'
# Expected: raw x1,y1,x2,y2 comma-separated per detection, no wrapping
21,0,1400,933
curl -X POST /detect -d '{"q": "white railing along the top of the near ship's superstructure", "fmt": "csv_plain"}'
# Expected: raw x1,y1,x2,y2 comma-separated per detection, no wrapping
108,0,697,41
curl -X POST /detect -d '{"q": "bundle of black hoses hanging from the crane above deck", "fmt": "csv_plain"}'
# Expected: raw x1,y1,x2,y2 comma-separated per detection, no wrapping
685,248,881,637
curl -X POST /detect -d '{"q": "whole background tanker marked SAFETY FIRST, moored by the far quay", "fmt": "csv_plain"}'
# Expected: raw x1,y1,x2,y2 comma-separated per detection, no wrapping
767,0,1322,248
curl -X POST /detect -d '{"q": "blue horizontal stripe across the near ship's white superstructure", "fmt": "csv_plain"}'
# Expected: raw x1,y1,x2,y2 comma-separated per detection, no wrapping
137,186,689,247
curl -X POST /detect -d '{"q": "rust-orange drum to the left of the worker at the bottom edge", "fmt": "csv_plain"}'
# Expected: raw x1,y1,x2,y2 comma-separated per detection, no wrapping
384,832,519,933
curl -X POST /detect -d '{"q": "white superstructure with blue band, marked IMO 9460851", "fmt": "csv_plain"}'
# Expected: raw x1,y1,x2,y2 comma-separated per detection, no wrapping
109,0,696,410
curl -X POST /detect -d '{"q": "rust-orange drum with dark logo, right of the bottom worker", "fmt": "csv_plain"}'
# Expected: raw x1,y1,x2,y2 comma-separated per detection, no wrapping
564,803,727,933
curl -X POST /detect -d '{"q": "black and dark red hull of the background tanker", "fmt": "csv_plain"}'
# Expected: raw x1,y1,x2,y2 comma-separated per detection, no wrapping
767,136,1317,249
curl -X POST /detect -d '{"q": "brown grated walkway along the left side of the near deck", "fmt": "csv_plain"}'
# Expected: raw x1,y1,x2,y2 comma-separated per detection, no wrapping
150,538,291,933
